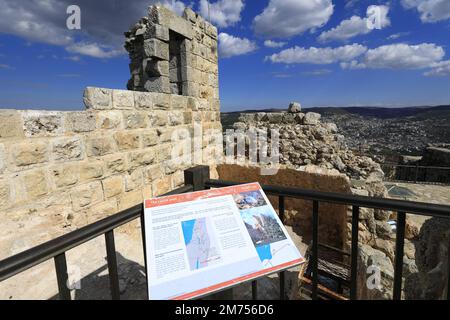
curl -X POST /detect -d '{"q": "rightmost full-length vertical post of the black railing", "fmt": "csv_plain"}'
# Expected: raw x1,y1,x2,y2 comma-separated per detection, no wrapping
393,212,406,300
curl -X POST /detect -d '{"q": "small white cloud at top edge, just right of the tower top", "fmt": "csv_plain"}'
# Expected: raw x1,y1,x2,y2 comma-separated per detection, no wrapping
199,0,244,28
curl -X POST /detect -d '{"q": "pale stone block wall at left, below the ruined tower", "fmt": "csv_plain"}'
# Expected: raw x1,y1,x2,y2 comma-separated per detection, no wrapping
0,88,222,259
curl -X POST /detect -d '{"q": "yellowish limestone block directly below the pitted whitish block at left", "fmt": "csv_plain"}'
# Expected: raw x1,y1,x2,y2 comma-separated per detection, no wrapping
12,140,49,167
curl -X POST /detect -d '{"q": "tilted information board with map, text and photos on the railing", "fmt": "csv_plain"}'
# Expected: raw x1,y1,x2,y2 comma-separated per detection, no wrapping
144,183,304,299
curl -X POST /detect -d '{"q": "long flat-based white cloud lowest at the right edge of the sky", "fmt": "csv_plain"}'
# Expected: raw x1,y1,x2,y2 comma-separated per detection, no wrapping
341,43,445,69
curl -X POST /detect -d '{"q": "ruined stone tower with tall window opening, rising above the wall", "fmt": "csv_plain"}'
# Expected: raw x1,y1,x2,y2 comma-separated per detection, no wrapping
125,5,219,104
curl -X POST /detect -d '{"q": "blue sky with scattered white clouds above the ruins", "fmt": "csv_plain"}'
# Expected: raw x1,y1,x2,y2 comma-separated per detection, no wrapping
0,0,450,111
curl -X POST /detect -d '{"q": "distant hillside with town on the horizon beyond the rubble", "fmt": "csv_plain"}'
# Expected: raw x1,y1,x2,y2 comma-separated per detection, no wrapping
222,105,450,161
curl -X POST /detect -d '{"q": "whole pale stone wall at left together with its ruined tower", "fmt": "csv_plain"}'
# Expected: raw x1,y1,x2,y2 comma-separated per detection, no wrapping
0,6,223,259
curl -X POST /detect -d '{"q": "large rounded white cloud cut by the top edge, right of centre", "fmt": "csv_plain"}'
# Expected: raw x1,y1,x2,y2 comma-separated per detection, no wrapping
253,0,334,38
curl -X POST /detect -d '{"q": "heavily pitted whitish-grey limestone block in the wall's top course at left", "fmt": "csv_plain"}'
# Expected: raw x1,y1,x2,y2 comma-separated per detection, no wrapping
22,110,64,137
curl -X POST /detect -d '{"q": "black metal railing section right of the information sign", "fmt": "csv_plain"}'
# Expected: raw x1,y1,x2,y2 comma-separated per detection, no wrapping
205,172,450,300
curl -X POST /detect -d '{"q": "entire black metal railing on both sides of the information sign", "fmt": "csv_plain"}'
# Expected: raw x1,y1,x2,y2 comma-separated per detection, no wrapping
0,166,450,300
